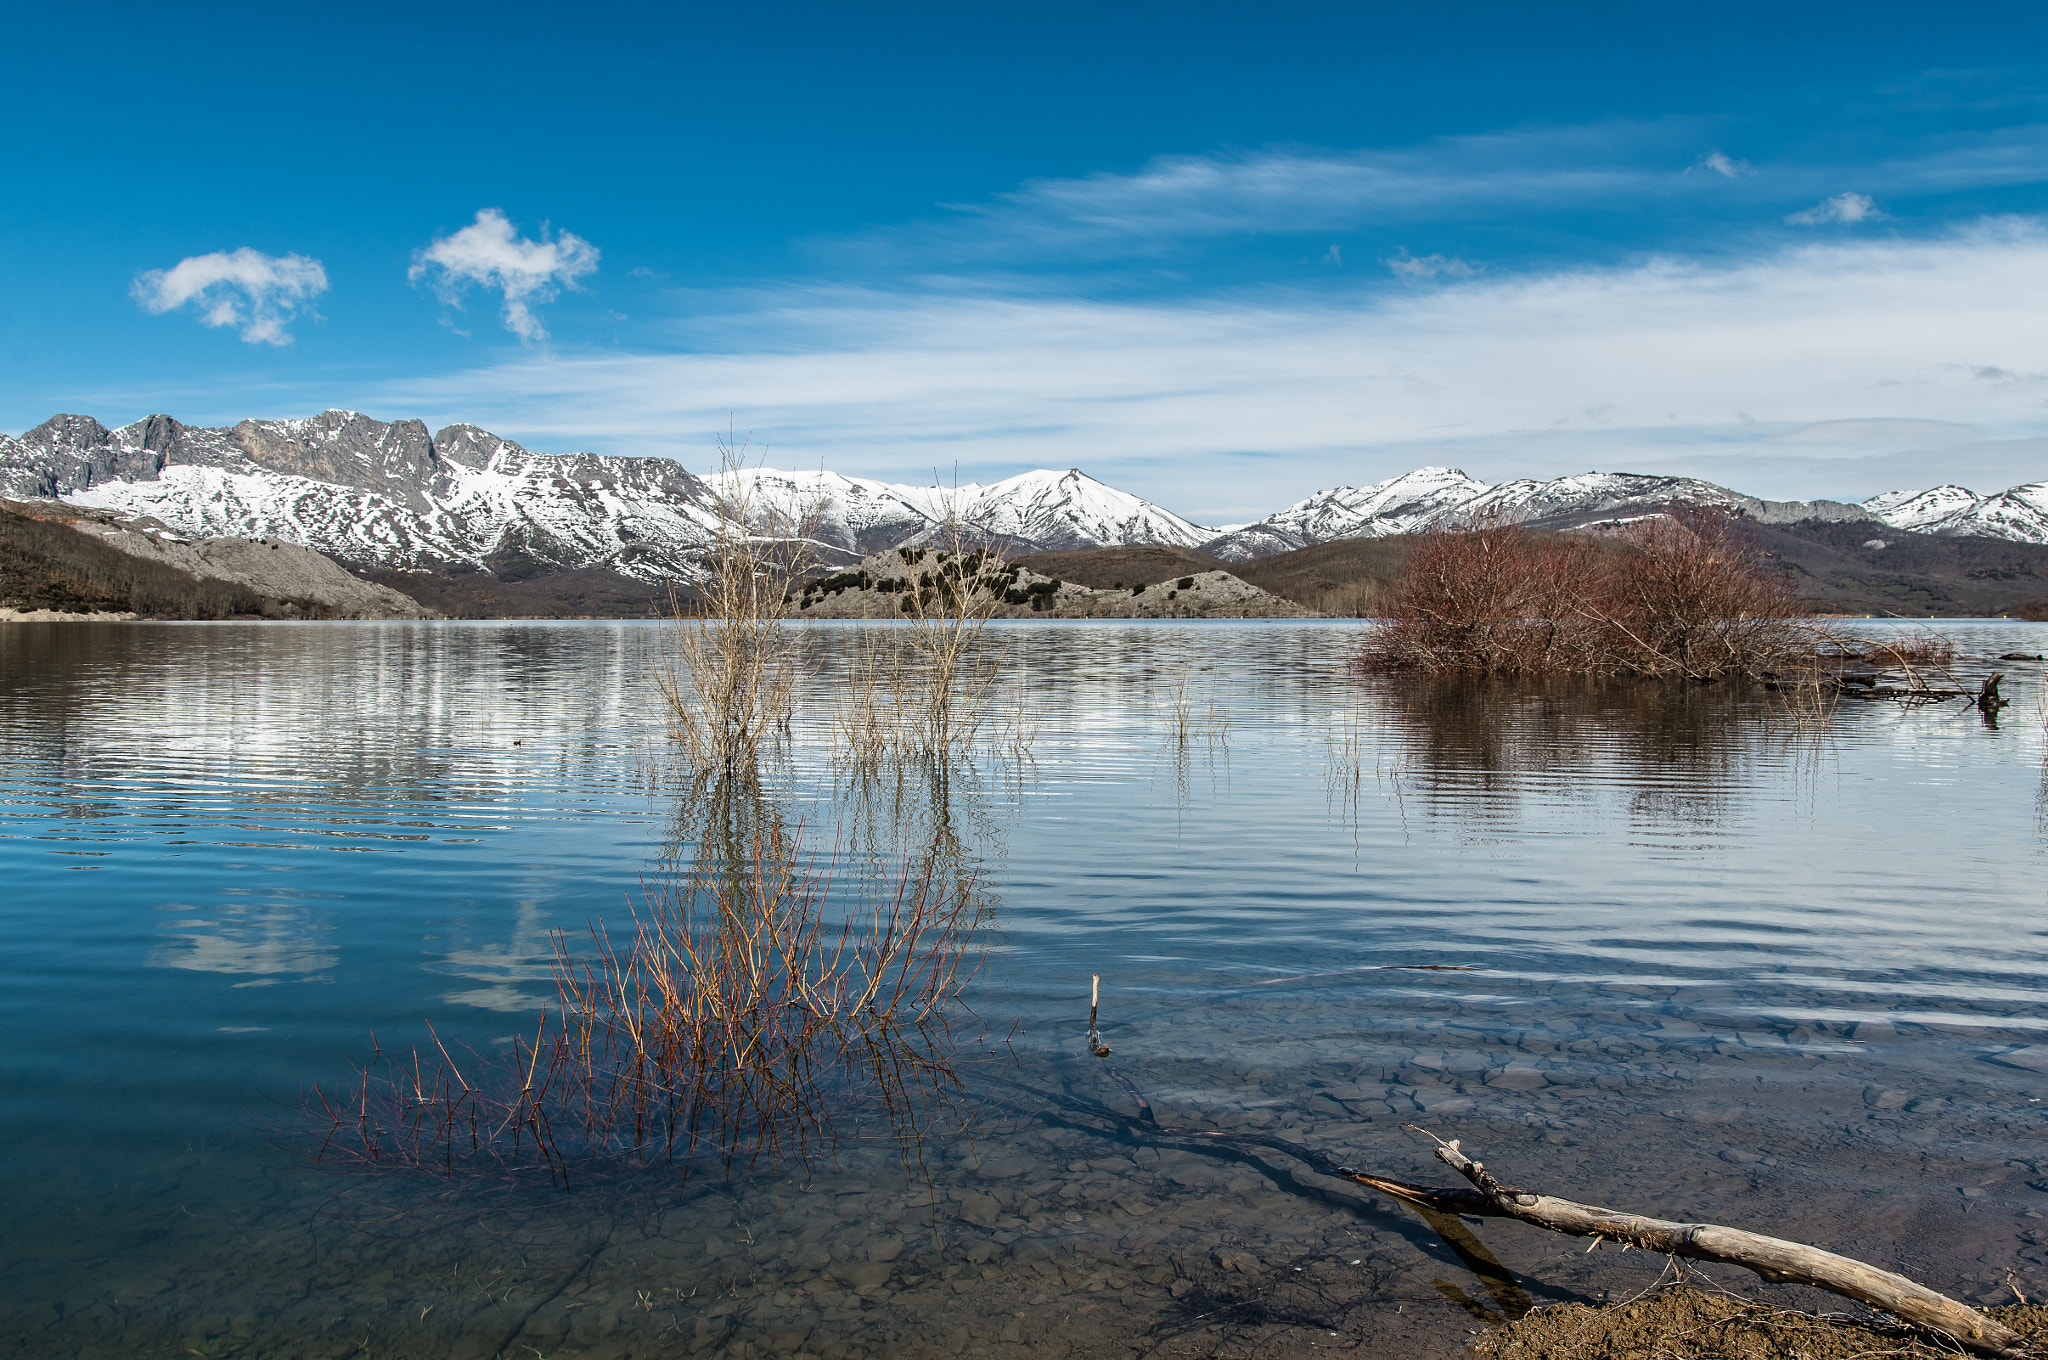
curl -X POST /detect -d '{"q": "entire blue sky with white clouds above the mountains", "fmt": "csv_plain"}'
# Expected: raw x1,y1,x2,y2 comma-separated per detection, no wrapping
0,4,2048,522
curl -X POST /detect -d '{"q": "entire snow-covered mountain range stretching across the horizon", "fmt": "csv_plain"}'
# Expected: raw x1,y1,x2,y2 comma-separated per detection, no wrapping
0,410,2048,582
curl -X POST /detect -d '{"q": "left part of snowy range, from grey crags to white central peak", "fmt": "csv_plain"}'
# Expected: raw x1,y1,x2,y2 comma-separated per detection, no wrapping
0,410,1212,580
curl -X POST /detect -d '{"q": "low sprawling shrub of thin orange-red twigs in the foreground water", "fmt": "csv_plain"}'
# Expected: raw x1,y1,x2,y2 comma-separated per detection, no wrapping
301,819,979,1184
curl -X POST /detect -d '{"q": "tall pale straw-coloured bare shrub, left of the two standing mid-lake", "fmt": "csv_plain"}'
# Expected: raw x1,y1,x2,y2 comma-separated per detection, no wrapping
653,438,817,770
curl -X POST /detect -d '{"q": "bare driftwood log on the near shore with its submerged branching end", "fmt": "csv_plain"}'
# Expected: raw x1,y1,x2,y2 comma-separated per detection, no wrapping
993,1065,2034,1360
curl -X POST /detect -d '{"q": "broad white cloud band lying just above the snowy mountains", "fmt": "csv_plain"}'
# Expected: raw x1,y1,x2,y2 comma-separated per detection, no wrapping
377,219,2048,508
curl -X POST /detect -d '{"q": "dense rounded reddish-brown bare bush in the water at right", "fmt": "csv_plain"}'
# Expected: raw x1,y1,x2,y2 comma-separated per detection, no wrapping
1358,508,1835,680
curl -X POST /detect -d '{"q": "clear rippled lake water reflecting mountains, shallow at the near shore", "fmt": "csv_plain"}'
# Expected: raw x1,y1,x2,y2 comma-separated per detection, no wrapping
0,623,2048,1358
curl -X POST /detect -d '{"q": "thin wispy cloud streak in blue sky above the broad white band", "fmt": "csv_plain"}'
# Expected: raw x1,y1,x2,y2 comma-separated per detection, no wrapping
819,117,2048,268
